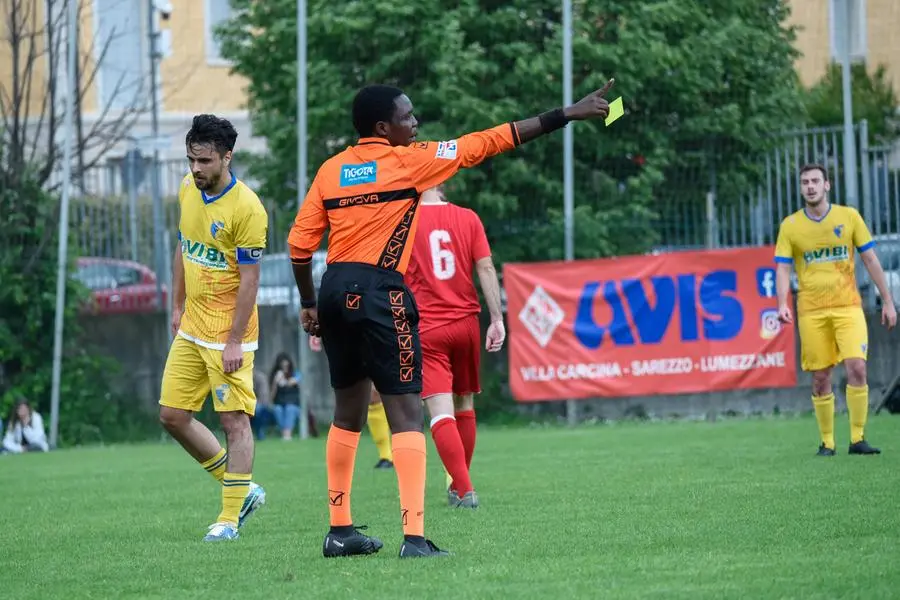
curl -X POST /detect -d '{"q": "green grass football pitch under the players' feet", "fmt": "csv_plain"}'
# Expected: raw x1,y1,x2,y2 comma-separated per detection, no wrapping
0,415,900,600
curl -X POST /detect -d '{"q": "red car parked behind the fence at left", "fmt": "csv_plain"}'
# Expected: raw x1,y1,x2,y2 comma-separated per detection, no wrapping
72,257,169,314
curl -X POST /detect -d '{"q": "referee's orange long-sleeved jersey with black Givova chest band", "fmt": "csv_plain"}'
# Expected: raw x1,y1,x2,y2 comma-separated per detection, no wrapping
288,123,519,274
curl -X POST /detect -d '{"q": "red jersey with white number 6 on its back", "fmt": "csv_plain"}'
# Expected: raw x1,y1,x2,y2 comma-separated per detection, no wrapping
405,203,491,331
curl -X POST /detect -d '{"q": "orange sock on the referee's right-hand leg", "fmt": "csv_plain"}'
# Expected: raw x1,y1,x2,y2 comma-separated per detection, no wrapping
392,431,425,537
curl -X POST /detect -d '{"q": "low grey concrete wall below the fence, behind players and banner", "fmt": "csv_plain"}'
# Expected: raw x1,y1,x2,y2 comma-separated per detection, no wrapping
84,307,900,422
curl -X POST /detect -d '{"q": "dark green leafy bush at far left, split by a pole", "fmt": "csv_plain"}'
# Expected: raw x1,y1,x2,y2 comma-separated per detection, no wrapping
0,172,153,444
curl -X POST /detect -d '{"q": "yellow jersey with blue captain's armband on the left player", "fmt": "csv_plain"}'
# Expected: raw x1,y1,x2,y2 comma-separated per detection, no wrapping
178,175,269,352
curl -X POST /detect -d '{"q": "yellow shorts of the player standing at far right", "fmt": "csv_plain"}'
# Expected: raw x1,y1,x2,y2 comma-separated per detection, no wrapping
797,307,869,371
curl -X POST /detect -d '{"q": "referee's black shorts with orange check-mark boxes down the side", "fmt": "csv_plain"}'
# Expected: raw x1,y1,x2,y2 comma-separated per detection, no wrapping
319,263,422,395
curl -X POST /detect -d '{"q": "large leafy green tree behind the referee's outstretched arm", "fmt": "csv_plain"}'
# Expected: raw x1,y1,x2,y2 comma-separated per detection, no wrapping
219,0,802,261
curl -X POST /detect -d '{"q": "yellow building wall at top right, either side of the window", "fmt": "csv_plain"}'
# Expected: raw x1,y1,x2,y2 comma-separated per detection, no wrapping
789,0,900,94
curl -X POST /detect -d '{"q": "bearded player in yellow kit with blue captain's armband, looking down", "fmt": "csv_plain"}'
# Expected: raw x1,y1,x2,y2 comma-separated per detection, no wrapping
159,115,268,541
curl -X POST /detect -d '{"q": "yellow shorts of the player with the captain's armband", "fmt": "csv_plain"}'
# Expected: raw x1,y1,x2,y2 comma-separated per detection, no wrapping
159,336,256,416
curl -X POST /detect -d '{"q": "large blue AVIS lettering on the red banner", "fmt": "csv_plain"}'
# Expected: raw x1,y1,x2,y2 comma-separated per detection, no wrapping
575,271,744,350
